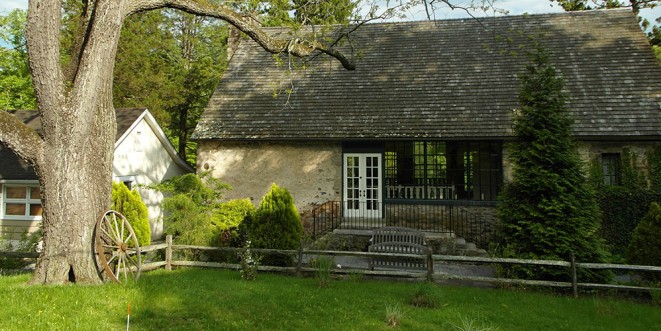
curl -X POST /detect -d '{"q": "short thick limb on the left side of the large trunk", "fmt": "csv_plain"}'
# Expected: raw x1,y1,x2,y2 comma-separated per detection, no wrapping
0,111,44,165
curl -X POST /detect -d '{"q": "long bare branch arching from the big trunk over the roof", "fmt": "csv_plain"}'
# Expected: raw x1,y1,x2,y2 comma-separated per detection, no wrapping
127,0,356,70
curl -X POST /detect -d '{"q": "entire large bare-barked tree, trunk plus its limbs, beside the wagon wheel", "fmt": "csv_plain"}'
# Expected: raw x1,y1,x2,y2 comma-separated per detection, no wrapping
0,0,354,284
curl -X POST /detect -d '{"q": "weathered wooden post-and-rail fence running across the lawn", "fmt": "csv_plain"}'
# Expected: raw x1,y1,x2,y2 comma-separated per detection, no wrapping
0,235,661,296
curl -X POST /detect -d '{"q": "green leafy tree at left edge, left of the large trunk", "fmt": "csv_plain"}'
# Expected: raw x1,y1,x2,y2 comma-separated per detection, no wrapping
0,9,36,109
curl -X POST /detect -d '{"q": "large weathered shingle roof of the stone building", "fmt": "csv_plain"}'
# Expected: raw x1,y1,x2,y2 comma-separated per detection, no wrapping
193,10,661,140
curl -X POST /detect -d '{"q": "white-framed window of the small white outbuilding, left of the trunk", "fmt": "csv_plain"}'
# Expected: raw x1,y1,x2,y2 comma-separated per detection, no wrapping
2,184,42,220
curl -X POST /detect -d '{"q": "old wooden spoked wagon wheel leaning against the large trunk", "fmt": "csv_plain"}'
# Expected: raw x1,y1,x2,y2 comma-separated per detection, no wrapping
94,210,142,283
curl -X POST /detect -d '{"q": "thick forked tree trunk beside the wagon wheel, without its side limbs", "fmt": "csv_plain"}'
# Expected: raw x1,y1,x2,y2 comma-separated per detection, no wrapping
27,0,124,284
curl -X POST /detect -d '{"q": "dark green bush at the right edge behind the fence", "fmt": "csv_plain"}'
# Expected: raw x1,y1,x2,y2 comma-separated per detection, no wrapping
627,202,661,281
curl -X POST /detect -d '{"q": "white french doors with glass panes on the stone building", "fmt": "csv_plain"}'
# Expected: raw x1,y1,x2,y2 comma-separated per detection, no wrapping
343,153,383,218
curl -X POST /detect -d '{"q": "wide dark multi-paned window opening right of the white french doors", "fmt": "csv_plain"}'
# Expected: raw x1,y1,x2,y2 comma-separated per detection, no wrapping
385,141,502,200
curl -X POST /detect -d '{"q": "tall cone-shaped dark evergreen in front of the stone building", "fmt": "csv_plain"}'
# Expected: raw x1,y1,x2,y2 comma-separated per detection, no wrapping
498,46,605,280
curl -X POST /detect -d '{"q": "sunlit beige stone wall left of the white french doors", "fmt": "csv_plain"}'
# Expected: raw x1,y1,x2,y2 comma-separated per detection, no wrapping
197,141,342,213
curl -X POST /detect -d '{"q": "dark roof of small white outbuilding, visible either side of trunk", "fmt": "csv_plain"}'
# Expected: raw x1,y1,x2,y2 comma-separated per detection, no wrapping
0,108,146,180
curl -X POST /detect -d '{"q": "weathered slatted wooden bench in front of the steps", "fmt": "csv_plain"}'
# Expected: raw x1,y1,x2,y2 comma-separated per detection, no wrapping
369,226,429,270
